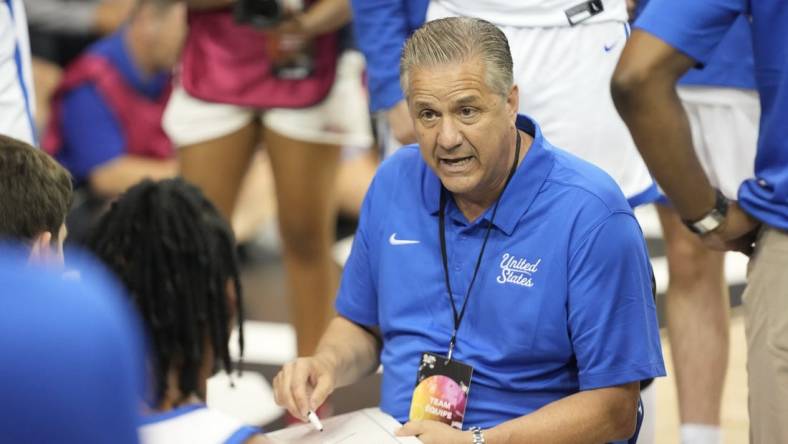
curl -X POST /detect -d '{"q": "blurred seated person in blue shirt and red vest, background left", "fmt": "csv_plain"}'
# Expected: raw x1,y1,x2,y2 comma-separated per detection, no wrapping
43,0,186,197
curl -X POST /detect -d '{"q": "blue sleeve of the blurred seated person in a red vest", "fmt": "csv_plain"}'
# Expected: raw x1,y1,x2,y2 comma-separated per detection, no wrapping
58,85,126,182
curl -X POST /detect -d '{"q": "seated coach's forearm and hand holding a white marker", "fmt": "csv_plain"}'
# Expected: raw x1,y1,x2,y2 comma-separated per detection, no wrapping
274,316,380,419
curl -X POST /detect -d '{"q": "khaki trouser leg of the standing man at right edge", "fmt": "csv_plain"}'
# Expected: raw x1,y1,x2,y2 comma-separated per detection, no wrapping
742,227,788,444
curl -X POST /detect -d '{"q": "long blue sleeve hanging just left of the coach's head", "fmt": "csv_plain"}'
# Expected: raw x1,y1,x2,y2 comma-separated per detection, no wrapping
351,0,429,112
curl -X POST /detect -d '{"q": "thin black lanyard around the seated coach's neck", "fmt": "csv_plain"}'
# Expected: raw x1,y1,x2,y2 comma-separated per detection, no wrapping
438,129,520,361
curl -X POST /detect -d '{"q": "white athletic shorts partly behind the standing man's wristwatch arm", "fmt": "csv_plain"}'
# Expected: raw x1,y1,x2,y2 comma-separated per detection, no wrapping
678,86,761,203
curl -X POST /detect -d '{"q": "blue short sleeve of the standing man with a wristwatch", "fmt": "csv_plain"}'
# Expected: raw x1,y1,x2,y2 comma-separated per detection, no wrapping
635,0,747,63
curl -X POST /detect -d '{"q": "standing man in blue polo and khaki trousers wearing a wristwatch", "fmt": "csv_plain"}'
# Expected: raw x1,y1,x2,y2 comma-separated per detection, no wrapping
613,0,788,443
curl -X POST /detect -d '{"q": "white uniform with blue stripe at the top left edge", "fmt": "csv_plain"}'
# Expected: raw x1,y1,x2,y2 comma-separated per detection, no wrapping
0,0,36,145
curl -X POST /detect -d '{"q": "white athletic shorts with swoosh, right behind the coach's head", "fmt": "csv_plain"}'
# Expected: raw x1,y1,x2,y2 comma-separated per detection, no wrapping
427,1,658,205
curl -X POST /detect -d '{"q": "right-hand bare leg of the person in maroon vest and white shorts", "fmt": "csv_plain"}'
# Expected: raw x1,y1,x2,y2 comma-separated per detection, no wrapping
265,129,340,356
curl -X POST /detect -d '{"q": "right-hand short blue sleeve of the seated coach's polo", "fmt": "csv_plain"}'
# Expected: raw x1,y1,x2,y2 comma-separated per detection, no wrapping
568,212,665,390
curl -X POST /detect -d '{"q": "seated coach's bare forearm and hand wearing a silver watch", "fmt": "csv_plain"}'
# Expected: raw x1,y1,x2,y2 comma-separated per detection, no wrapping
398,382,640,444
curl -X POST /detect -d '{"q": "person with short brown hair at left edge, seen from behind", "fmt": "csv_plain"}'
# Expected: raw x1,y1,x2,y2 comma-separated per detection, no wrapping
0,135,73,263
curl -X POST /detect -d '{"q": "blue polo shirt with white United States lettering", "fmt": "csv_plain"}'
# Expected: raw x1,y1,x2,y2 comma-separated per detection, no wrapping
336,117,665,427
